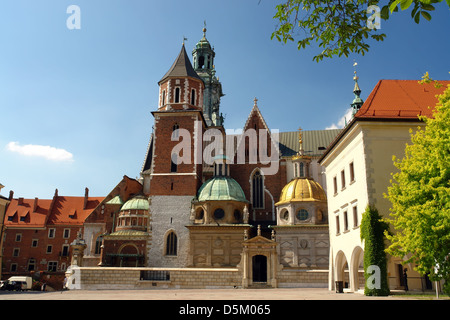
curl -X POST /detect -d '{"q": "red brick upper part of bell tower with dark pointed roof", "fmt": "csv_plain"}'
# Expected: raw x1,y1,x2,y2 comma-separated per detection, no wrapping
149,43,206,196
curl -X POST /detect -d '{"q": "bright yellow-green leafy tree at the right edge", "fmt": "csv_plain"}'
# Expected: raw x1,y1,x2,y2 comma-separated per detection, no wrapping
385,79,450,292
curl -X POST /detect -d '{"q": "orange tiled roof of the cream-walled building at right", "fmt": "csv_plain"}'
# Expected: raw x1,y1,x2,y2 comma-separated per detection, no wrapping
355,80,450,120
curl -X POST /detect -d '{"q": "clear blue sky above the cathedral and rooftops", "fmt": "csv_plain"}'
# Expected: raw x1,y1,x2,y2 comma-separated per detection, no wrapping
0,0,450,198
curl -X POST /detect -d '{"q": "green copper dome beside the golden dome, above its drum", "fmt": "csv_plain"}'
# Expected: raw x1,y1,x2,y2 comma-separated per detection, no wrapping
198,177,248,202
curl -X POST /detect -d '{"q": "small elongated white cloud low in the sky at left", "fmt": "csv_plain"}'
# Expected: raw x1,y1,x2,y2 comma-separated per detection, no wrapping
6,142,73,162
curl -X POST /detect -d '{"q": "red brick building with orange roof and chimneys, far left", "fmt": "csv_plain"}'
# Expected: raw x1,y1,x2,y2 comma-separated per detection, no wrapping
2,188,104,287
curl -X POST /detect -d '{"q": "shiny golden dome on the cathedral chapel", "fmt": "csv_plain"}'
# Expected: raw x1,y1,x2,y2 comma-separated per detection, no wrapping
275,178,327,205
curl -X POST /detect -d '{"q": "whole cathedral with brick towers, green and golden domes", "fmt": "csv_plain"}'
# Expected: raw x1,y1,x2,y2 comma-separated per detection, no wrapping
83,28,340,287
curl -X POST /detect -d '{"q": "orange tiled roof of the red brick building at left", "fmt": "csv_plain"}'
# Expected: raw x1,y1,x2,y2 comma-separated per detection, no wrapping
5,195,103,228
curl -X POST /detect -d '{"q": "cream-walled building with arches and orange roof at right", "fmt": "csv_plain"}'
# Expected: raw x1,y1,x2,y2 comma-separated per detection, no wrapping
319,76,450,291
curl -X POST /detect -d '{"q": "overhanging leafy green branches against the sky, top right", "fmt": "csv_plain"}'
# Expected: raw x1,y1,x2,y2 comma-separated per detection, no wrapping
272,0,450,62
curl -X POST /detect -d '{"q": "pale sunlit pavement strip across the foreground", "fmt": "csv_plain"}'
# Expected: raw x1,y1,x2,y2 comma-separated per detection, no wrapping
0,288,411,300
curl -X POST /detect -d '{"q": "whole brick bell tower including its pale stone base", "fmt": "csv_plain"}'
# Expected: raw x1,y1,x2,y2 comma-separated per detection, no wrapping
141,43,207,267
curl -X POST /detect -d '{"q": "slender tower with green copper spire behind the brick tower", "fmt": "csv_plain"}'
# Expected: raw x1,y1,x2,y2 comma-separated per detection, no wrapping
192,25,224,126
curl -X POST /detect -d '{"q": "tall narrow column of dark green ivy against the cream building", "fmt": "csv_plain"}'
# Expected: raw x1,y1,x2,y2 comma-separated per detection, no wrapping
360,206,389,296
